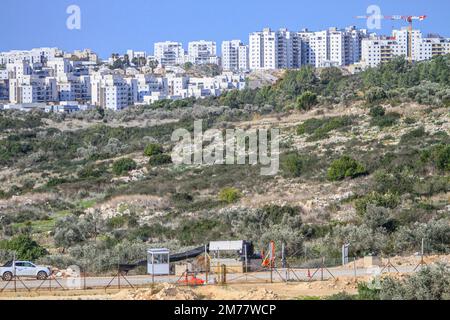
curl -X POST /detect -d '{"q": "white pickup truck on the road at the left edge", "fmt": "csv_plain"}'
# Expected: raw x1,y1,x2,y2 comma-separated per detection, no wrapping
0,261,52,281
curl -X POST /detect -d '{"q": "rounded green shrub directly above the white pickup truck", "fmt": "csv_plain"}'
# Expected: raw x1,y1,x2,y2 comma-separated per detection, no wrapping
0,235,48,261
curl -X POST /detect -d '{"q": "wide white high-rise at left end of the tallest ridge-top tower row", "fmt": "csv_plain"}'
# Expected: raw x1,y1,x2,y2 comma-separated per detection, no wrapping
249,28,302,70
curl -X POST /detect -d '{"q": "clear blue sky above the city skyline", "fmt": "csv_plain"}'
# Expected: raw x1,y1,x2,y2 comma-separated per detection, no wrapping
0,0,450,58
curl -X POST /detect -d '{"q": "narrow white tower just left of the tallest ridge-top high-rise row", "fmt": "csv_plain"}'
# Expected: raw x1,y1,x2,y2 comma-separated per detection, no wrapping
222,40,249,71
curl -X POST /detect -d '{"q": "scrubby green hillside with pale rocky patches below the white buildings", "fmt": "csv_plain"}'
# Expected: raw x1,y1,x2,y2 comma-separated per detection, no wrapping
0,56,450,273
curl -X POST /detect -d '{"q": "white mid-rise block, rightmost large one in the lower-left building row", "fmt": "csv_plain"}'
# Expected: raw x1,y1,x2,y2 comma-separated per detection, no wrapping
91,74,137,111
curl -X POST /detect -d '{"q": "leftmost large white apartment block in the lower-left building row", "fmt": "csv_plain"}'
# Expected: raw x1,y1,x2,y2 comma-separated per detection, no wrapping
9,75,58,104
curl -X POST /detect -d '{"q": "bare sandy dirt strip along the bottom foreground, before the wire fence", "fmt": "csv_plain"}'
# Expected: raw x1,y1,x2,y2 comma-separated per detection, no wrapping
0,278,357,300
